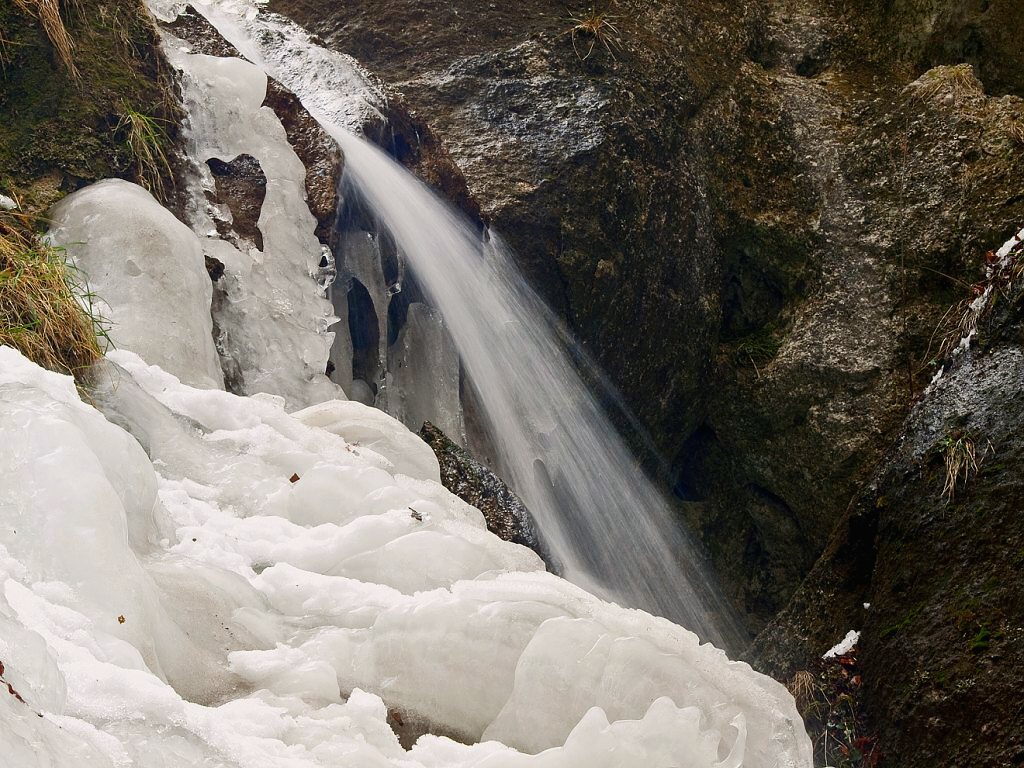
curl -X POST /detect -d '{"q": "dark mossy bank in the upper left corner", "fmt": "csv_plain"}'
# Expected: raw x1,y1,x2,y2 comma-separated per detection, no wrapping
0,0,177,202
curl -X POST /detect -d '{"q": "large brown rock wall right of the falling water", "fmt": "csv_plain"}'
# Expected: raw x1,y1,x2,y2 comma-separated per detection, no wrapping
270,0,1024,631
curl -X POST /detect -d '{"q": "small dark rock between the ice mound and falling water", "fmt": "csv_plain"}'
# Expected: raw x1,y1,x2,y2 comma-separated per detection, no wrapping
420,422,548,560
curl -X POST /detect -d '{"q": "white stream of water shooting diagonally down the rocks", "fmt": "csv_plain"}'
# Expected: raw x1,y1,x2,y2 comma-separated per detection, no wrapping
186,4,738,645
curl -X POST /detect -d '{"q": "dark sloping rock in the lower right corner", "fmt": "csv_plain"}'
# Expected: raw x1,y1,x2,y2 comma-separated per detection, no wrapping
751,259,1024,768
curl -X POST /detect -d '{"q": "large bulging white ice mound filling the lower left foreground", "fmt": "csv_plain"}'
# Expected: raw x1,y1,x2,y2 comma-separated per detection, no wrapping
0,347,811,768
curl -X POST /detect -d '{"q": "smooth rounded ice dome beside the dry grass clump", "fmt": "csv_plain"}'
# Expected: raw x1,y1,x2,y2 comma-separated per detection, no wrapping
49,179,224,388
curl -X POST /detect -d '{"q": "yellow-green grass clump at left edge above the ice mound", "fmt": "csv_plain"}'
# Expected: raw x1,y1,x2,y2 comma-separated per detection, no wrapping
0,205,106,375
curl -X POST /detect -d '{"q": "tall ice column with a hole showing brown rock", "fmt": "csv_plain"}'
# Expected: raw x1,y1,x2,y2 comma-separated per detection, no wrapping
167,42,343,408
